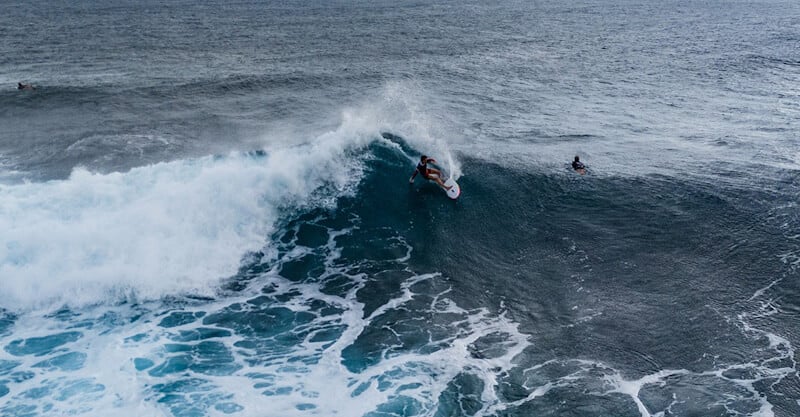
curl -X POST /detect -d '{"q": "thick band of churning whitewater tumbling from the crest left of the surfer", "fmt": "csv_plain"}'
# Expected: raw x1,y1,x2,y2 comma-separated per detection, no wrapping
0,116,378,309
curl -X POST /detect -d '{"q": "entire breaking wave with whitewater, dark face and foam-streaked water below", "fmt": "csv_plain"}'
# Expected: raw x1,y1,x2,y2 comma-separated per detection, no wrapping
0,133,797,416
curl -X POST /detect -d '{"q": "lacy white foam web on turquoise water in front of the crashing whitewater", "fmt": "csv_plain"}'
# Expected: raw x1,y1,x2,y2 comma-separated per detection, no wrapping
0,218,532,417
